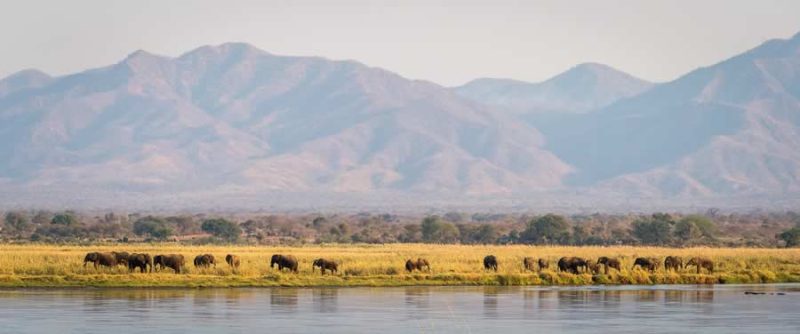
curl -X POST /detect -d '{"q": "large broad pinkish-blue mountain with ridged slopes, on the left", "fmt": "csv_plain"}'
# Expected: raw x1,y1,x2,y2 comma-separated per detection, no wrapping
0,44,570,201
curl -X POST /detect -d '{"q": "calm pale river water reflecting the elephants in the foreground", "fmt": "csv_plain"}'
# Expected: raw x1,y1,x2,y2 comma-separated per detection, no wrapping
0,284,800,334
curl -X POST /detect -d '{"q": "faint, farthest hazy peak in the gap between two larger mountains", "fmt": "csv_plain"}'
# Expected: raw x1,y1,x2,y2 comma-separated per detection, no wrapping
455,63,653,114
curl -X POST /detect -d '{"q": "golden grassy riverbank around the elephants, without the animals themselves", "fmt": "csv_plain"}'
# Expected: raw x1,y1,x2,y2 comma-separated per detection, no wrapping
0,244,800,287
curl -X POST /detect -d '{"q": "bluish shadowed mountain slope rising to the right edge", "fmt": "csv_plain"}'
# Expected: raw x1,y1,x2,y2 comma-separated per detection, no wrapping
542,34,800,196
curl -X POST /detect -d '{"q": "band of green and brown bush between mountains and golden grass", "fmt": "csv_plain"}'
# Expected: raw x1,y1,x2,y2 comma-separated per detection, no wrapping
0,210,800,247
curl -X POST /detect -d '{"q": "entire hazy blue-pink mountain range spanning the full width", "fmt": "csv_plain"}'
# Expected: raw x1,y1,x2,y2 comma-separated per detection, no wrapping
0,34,800,206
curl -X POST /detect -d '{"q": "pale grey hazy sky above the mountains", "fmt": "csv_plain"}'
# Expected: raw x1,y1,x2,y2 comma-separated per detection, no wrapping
0,0,800,85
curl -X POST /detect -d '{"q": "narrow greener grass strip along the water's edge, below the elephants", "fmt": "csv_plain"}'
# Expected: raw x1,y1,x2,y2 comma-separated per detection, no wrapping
0,272,800,289
